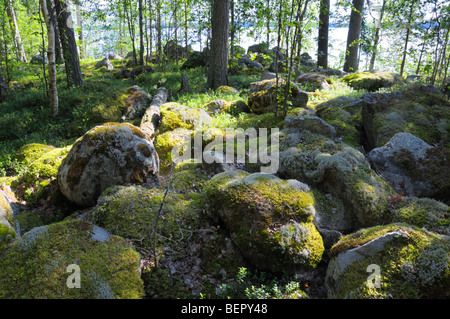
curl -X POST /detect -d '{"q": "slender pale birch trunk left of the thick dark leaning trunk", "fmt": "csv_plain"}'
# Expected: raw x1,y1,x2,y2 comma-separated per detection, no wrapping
39,0,59,117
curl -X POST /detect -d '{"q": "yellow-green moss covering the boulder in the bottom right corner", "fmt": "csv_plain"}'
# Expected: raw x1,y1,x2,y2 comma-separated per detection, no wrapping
331,224,450,299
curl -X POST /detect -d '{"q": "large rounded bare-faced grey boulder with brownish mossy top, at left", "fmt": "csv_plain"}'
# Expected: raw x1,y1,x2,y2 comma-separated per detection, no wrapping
58,123,159,206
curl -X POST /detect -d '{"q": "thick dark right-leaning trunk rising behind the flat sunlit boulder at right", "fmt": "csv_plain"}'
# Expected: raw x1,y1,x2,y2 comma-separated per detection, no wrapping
344,0,364,72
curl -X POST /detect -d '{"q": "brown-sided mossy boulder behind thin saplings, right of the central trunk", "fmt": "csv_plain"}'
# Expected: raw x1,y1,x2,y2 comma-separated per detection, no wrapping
248,79,309,114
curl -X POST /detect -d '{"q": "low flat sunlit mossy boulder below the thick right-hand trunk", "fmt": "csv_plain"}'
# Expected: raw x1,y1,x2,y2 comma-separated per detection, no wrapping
342,70,403,92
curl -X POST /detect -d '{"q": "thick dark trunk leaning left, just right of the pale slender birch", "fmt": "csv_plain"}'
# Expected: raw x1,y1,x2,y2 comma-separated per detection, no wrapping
55,0,83,87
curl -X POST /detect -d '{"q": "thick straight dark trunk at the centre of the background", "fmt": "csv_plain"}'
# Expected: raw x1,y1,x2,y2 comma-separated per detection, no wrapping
207,0,230,89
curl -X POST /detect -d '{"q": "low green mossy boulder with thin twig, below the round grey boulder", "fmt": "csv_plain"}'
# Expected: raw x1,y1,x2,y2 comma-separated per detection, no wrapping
89,186,201,254
